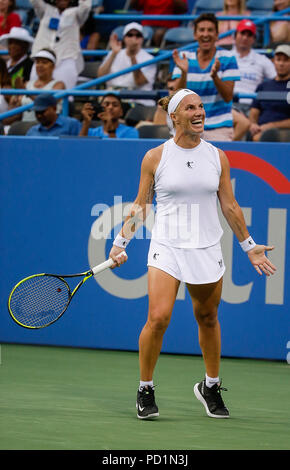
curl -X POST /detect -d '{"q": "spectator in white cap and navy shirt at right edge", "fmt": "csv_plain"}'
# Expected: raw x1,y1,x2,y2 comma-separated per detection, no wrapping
249,44,290,142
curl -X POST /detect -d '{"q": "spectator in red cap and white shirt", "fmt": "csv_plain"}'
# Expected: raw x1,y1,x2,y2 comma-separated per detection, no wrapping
232,20,276,113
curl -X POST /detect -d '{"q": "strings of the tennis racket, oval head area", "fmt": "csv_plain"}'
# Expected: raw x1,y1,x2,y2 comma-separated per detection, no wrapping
10,275,70,328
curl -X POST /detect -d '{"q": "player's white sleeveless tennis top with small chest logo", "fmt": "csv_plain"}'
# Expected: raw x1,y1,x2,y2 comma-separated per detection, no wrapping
151,138,223,248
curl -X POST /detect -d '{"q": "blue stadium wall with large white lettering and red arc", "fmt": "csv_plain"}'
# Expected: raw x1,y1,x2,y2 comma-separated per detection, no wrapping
0,136,290,360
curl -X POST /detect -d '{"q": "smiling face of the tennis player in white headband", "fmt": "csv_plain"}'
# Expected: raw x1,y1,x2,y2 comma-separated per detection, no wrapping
173,95,205,134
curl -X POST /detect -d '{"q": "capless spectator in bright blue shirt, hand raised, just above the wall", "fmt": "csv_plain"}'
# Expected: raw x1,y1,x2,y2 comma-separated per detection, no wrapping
79,94,139,139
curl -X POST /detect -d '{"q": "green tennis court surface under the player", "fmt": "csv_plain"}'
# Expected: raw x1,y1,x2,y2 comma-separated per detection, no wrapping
0,344,290,450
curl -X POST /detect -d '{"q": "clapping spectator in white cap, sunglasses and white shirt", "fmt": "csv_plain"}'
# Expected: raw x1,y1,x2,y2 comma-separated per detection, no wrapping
98,23,157,106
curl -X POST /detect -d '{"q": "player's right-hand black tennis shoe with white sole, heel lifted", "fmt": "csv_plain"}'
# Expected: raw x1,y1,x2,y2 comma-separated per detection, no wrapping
193,379,230,418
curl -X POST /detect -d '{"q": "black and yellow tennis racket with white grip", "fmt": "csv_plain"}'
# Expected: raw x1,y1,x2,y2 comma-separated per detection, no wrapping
8,251,126,329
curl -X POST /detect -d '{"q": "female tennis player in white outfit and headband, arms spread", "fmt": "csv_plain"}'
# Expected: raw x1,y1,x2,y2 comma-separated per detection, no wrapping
110,89,276,419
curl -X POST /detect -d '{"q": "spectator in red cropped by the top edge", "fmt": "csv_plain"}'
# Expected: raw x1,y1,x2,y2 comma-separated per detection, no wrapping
130,0,188,47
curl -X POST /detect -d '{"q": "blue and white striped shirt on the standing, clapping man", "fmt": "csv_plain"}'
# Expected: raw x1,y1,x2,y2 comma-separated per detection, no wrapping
172,48,240,130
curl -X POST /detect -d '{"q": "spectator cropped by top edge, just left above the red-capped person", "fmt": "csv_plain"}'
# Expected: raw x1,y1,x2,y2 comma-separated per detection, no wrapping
216,0,250,46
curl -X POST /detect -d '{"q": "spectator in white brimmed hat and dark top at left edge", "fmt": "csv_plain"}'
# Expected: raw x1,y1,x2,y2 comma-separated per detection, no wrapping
0,26,33,88
